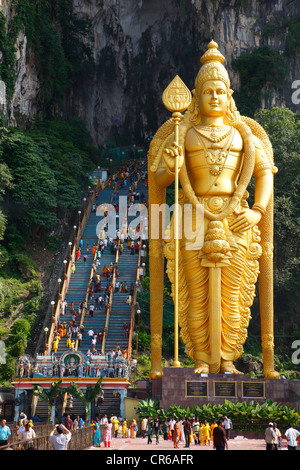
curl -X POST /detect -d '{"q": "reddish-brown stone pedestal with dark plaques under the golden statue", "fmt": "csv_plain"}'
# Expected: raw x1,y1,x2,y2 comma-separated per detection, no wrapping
151,367,300,410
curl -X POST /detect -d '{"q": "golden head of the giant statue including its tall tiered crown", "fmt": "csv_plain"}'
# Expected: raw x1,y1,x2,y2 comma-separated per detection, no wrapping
190,41,238,124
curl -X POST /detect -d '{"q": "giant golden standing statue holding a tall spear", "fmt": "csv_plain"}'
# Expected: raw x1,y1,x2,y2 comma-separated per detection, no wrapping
148,41,279,379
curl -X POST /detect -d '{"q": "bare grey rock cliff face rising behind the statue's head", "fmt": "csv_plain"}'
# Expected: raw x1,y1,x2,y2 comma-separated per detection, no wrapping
2,0,300,145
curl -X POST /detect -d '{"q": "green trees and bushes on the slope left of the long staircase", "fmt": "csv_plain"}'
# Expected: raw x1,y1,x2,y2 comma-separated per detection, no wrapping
0,115,98,382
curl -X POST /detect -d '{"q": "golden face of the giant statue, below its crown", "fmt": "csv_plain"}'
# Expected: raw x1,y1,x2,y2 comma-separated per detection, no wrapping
199,80,228,117
